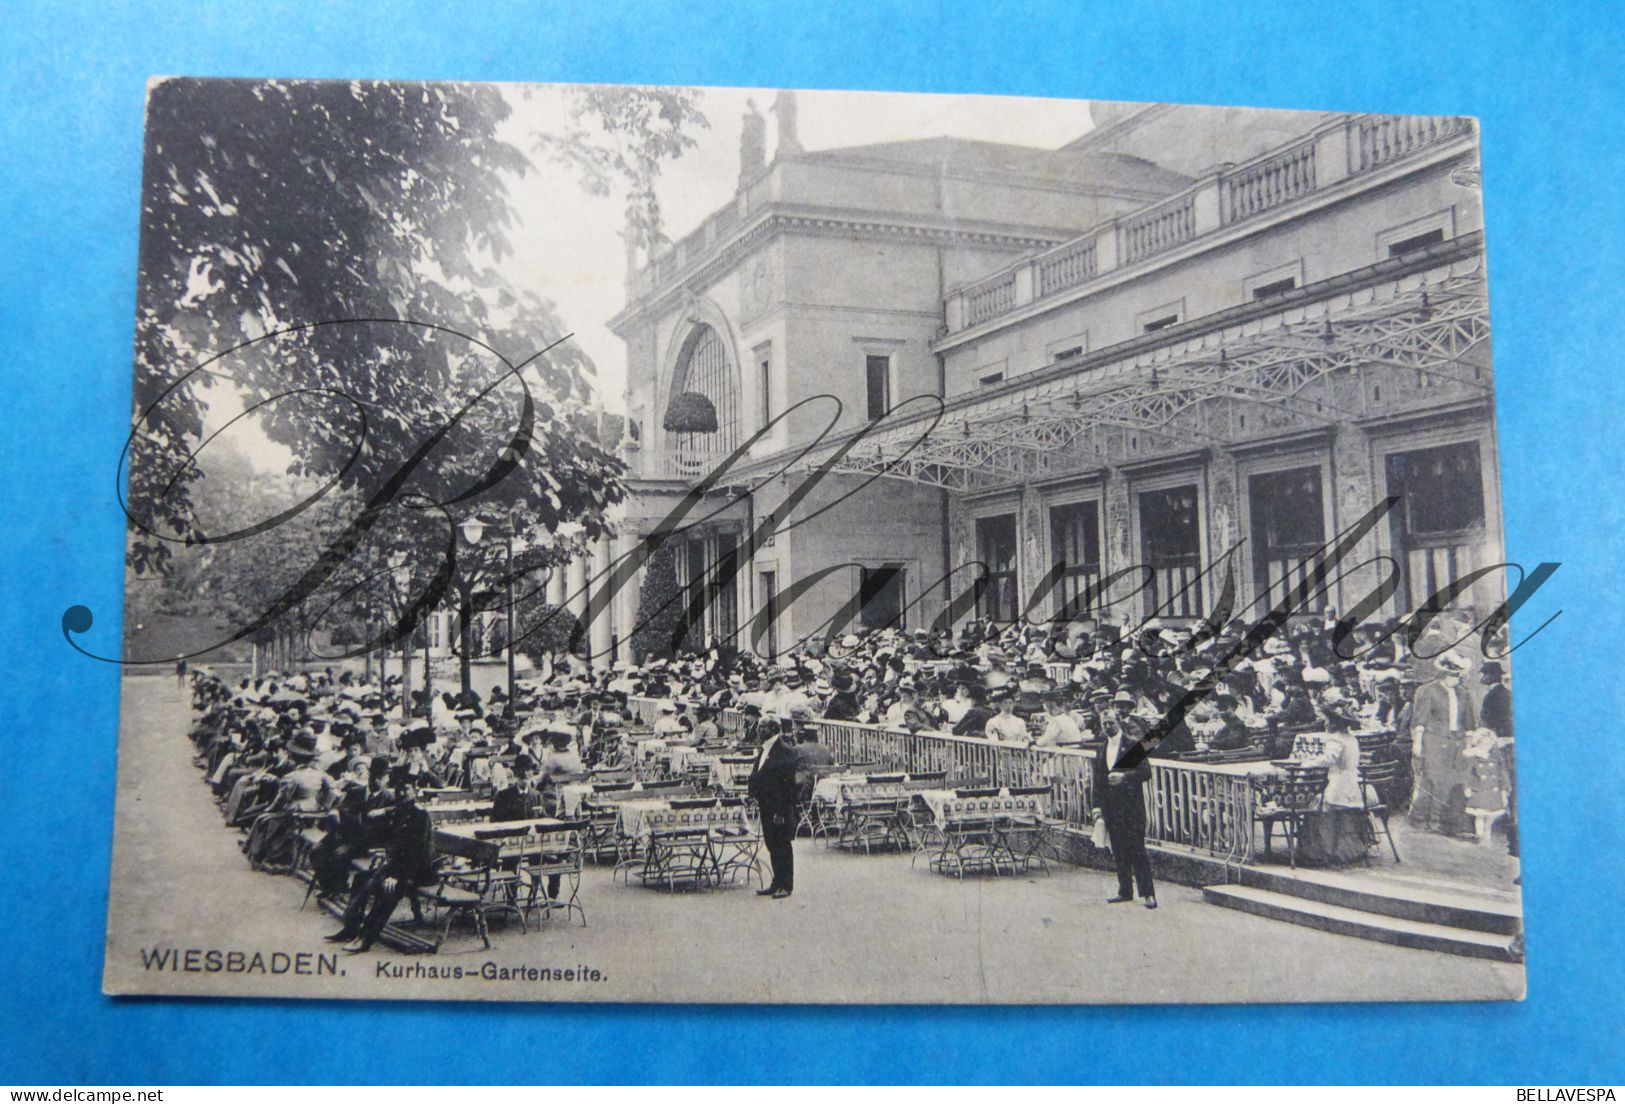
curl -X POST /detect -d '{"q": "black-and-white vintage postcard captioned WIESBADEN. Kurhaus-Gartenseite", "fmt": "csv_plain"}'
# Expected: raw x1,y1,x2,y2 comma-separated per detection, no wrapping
98,78,1521,1003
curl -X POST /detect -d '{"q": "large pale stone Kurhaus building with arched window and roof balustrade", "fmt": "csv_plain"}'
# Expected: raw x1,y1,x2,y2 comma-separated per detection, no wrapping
572,104,1502,655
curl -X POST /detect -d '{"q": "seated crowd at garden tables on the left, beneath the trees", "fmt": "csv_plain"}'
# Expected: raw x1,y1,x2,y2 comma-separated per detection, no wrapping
190,668,626,951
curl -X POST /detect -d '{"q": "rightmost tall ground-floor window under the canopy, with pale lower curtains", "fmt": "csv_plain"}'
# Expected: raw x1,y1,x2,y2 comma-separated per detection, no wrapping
1388,441,1484,610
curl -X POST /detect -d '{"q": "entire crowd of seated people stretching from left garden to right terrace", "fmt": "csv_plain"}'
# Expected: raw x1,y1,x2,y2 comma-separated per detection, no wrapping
192,604,1510,938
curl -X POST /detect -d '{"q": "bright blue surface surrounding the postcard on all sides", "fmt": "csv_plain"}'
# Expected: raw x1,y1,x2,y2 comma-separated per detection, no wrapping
0,0,1625,1084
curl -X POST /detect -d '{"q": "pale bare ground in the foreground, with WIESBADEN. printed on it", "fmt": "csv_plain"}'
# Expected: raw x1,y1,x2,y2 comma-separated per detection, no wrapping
109,676,1523,1003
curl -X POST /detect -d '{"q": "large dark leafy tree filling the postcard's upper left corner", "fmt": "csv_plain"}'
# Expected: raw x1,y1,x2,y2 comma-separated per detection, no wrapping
127,80,704,678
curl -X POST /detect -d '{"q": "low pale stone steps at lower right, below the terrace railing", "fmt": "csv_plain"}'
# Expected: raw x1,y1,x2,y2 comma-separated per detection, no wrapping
1203,871,1523,963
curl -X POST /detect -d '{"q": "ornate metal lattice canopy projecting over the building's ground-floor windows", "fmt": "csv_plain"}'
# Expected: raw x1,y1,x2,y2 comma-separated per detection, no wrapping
773,254,1492,493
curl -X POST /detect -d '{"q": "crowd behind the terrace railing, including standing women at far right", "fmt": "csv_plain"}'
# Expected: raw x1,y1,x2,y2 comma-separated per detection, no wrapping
603,611,1511,855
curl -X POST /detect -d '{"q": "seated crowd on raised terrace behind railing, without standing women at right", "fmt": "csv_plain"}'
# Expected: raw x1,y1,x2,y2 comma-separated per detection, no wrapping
606,621,1415,758
